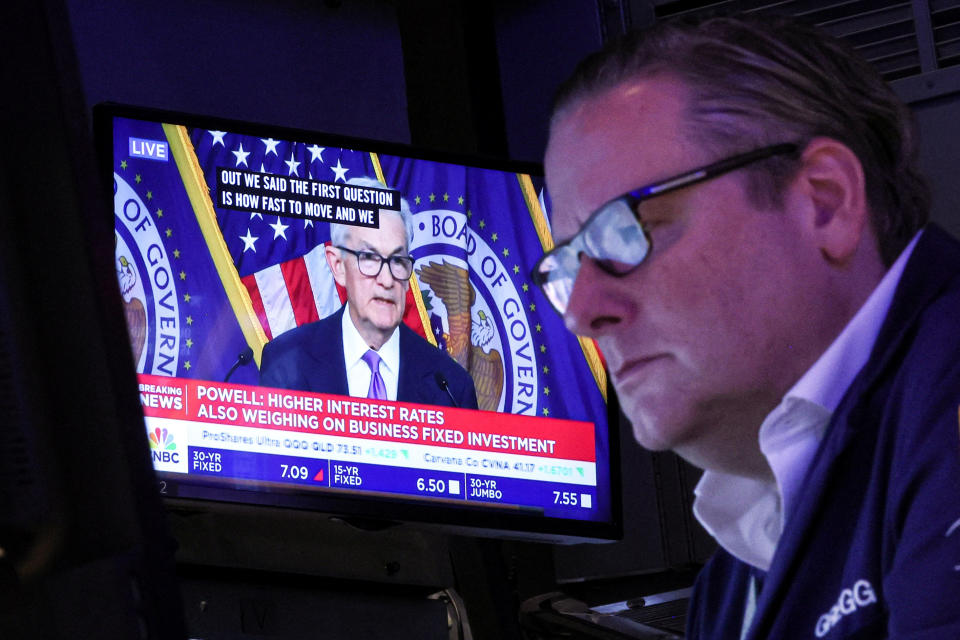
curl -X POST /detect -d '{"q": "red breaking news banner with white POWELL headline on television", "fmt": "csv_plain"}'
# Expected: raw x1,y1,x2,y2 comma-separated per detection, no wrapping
138,374,596,462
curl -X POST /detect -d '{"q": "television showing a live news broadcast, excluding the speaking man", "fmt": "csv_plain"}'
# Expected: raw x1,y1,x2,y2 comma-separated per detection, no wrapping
94,104,621,542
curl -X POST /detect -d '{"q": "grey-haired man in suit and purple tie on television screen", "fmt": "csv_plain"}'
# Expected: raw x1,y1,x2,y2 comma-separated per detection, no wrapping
260,178,477,409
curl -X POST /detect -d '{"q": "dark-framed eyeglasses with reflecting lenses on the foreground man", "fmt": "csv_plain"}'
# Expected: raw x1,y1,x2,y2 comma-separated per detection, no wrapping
530,143,799,314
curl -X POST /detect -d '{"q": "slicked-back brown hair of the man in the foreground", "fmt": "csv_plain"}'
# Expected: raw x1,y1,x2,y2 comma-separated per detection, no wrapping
553,15,930,266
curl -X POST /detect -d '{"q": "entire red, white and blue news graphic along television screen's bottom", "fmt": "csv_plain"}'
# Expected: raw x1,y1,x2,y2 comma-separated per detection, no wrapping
140,375,596,517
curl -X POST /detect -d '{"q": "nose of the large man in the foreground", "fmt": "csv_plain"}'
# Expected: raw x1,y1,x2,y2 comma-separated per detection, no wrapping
563,256,628,338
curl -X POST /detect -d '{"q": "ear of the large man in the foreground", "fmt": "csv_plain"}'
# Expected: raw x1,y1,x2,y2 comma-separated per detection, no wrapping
794,138,870,265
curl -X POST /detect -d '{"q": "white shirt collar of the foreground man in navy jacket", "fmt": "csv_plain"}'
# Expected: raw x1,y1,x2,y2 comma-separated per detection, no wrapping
693,232,922,571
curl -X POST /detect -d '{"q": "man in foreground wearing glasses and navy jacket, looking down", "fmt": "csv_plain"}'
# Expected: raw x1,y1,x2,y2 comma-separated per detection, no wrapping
533,12,960,639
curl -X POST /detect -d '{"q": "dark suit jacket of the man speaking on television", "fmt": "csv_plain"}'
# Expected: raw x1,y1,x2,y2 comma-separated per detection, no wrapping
260,307,477,409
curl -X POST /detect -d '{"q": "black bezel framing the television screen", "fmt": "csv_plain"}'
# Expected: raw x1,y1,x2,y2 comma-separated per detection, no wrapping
92,102,623,544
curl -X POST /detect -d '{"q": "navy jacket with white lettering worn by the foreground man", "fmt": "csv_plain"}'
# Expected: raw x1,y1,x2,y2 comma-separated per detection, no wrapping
687,226,960,640
